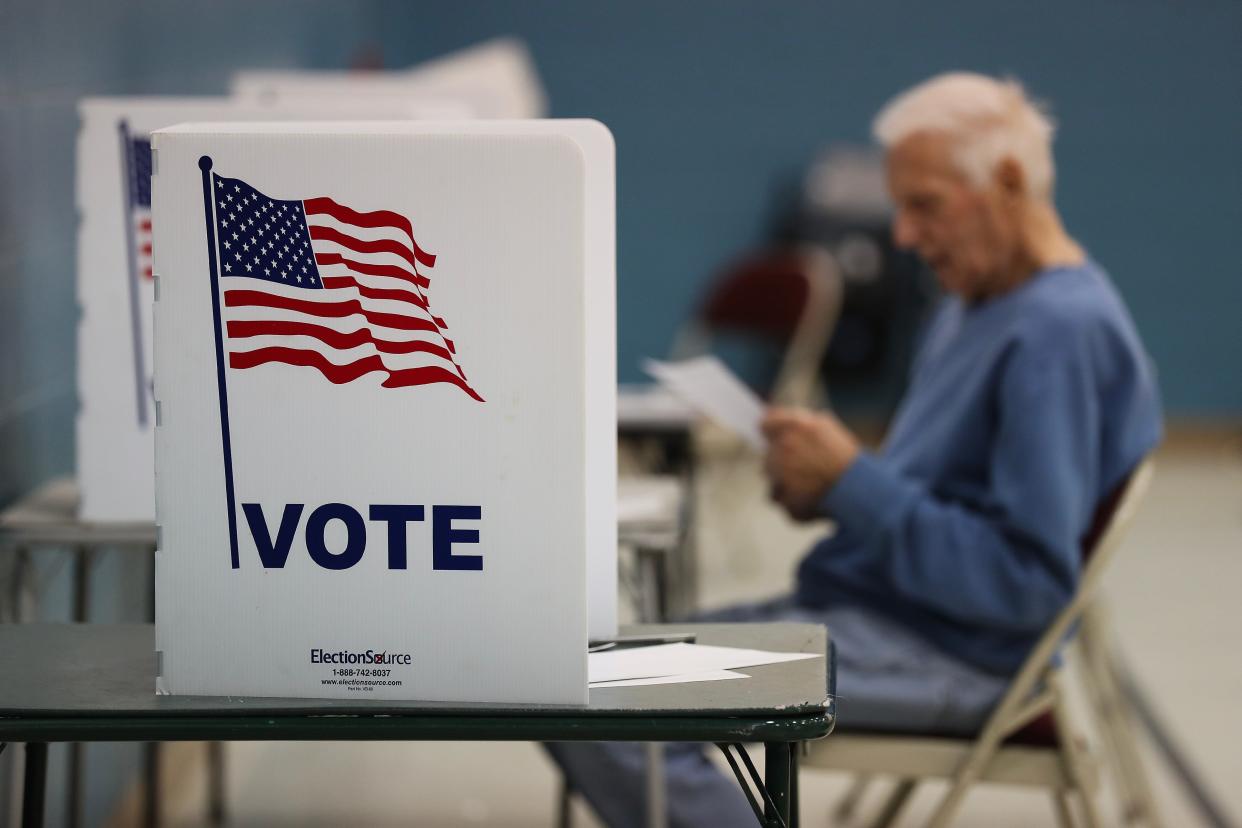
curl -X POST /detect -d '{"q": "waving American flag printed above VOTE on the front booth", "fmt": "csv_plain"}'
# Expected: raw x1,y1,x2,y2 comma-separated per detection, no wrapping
209,173,483,402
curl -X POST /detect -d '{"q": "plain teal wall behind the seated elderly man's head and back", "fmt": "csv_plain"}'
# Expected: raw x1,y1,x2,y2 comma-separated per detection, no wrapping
378,0,1242,417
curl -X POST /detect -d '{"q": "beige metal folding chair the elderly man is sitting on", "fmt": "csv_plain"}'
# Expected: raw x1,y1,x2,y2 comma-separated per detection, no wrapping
802,461,1151,828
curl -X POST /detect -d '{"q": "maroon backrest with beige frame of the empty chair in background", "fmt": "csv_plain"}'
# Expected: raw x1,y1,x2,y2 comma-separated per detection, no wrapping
673,245,843,406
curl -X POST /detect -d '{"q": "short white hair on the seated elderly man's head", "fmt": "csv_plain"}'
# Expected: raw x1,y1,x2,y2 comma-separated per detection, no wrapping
872,72,1053,199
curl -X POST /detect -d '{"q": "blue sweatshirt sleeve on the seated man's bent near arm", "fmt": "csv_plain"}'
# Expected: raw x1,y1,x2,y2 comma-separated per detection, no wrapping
823,336,1100,632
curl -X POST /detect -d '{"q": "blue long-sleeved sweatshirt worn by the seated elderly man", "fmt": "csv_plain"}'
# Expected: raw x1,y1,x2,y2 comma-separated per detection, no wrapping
797,263,1161,674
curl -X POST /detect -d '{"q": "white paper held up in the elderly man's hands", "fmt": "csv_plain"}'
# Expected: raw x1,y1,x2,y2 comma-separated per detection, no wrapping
642,355,765,451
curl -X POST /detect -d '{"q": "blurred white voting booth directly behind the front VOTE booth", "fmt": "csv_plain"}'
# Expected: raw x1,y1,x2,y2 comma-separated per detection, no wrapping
76,97,443,521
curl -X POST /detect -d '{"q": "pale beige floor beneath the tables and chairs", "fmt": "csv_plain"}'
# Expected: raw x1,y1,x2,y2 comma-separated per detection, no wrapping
157,436,1242,828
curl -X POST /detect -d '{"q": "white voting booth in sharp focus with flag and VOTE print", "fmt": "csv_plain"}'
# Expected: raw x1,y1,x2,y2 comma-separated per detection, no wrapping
152,120,616,704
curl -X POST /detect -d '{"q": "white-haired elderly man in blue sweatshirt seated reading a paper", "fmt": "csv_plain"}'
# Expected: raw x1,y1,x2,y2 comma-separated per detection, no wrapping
549,73,1160,826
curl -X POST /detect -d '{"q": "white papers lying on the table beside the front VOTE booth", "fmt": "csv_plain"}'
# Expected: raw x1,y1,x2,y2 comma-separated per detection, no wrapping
586,643,821,684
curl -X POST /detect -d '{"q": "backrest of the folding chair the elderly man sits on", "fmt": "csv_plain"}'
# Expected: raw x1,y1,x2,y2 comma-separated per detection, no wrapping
984,458,1153,737
